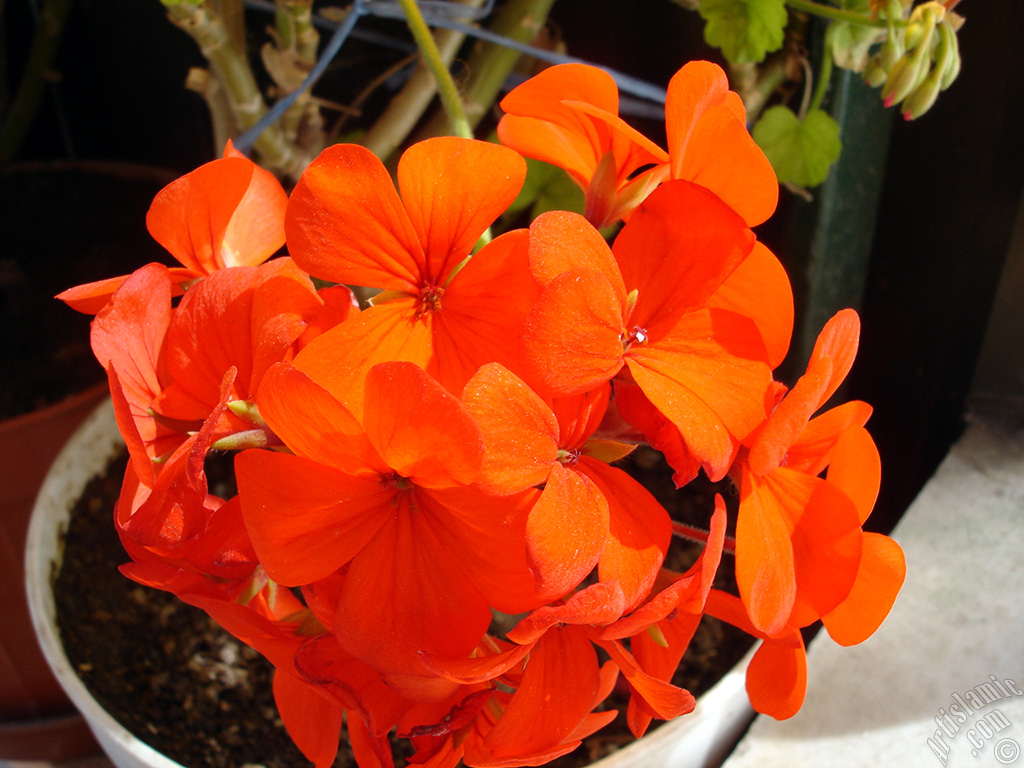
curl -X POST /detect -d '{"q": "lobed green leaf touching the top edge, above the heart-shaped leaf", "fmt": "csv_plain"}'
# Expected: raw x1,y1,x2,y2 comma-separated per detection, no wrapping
700,0,787,63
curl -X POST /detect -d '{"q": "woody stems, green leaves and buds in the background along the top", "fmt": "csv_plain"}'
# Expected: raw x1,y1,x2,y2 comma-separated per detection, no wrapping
0,0,963,191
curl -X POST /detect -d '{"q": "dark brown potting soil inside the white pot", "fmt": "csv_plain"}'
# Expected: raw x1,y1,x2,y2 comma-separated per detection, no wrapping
55,450,751,768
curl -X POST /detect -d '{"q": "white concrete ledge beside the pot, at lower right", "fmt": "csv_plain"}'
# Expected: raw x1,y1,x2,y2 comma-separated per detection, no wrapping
725,420,1024,768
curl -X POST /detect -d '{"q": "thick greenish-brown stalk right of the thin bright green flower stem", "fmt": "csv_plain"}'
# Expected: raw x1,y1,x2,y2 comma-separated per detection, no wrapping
417,0,555,138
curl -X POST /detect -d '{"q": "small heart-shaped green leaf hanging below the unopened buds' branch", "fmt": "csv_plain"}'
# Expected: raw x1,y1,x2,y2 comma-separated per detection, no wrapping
753,106,843,187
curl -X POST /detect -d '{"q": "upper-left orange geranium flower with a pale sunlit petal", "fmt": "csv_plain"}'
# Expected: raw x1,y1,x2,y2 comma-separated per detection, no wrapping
57,141,288,314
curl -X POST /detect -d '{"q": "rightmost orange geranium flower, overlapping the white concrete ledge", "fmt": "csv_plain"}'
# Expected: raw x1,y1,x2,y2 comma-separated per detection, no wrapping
734,309,903,643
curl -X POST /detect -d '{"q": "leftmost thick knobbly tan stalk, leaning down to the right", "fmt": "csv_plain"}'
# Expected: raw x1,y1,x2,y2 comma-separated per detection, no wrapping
167,3,309,177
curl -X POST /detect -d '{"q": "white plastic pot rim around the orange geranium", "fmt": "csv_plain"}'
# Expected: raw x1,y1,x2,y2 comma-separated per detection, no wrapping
26,400,754,768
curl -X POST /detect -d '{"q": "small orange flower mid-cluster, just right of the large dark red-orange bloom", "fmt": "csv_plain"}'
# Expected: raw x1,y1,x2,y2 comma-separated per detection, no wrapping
463,364,672,610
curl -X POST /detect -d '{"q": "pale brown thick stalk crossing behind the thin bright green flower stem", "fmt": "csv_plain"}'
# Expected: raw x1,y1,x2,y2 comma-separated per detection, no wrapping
361,0,482,160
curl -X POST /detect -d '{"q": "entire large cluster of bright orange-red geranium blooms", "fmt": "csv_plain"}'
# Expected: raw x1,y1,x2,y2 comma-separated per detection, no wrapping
60,62,903,768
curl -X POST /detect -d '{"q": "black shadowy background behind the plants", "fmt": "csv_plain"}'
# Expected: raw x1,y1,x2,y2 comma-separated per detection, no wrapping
0,0,1024,529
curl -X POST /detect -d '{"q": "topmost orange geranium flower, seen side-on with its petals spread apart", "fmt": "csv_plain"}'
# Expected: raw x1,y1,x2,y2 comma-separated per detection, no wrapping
498,61,778,227
